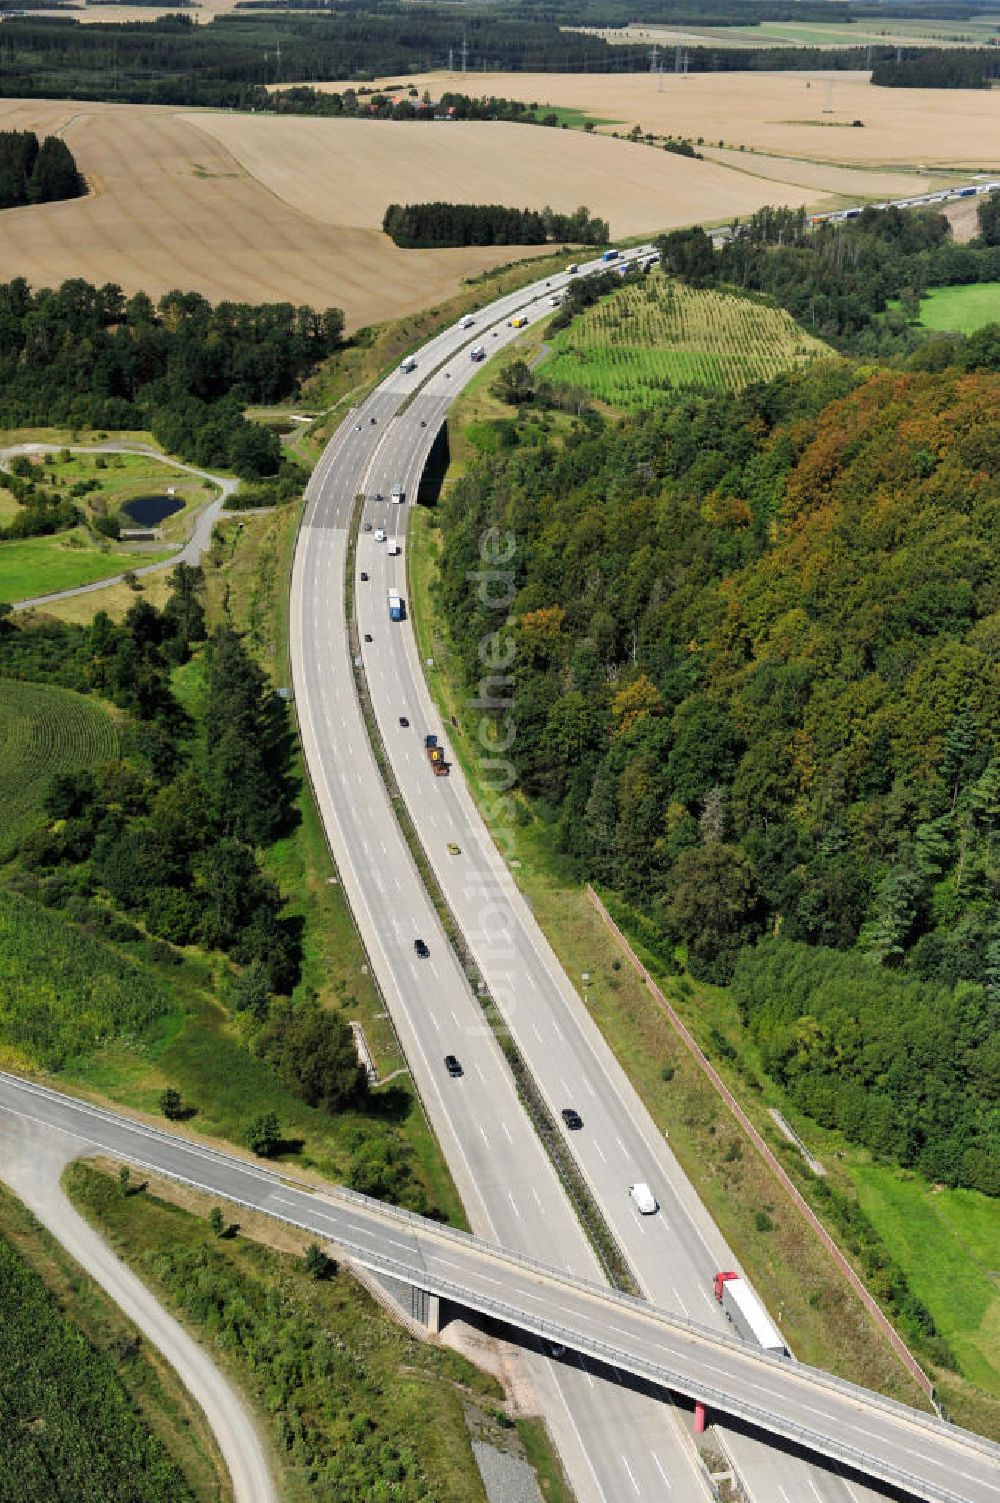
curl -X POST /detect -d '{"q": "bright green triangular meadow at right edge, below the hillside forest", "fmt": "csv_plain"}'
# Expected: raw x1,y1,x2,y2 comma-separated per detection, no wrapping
848,1163,1000,1396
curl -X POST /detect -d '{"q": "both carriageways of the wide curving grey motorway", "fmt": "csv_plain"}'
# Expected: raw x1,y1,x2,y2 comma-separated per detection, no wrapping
292,248,908,1503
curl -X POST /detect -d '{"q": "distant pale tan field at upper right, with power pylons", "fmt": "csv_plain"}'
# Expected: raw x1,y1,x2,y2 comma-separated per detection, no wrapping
321,72,1000,171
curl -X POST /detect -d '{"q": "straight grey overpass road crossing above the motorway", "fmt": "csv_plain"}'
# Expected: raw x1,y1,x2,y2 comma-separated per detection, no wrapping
0,1073,1000,1503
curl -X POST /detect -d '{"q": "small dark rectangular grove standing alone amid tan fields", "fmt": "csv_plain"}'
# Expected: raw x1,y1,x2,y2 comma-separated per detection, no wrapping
382,203,609,249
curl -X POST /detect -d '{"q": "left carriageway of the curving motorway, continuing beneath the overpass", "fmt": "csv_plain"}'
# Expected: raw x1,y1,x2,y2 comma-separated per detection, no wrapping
290,249,718,1503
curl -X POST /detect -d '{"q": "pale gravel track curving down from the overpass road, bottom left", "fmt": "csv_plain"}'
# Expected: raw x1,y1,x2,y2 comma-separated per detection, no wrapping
0,1112,278,1503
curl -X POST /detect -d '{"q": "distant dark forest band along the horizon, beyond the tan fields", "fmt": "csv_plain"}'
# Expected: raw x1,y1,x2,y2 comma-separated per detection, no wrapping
0,0,895,113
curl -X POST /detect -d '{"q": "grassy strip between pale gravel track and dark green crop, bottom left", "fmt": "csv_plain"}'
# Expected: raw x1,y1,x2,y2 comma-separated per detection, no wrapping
0,1189,225,1503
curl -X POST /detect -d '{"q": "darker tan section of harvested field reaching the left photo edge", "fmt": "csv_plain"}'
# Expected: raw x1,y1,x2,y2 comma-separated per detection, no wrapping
0,101,550,328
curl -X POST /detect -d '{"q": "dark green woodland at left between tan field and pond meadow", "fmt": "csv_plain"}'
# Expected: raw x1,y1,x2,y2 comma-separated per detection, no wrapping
0,278,344,479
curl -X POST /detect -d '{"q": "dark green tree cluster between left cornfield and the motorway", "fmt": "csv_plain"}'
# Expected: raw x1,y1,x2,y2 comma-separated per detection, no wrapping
0,586,298,997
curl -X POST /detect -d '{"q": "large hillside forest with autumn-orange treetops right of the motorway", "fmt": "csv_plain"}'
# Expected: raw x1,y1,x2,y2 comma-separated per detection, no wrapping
441,357,1000,1193
